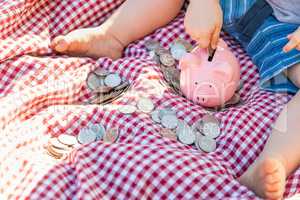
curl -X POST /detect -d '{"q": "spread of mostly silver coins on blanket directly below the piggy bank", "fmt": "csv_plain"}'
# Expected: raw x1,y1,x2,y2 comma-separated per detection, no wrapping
151,108,221,153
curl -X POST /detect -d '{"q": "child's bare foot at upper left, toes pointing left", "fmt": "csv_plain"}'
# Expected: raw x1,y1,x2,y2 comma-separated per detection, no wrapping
50,27,124,59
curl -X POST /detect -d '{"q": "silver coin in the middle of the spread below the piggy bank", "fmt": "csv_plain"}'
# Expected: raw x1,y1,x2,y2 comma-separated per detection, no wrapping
176,122,196,145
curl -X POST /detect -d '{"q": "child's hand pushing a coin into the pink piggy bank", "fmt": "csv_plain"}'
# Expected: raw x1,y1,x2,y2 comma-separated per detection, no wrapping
184,0,223,49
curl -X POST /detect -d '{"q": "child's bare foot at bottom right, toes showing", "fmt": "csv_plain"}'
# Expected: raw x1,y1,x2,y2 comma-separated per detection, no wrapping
238,158,286,200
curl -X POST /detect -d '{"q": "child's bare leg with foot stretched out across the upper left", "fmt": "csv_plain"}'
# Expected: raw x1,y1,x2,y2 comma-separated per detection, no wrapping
51,0,184,59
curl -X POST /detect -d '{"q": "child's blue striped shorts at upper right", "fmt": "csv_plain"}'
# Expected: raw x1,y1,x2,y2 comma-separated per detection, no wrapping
220,0,300,93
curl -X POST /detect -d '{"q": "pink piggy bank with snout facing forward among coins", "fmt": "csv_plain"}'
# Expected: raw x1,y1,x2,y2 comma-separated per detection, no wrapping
179,40,240,107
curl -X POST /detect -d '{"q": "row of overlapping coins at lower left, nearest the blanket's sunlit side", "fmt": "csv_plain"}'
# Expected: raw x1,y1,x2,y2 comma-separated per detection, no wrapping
45,124,119,159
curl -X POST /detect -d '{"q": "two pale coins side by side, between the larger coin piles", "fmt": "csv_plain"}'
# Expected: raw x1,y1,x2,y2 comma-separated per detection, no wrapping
118,97,155,114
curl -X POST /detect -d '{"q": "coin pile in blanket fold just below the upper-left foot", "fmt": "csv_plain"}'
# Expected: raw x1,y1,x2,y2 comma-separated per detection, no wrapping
86,69,130,104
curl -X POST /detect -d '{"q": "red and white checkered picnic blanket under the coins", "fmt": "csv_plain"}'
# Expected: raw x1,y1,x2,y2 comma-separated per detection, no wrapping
0,0,300,199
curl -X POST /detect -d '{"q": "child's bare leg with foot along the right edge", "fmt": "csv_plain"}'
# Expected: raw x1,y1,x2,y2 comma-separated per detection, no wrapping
239,64,300,199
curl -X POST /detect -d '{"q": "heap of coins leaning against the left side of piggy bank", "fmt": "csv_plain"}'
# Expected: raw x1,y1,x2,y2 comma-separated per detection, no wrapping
145,39,193,95
